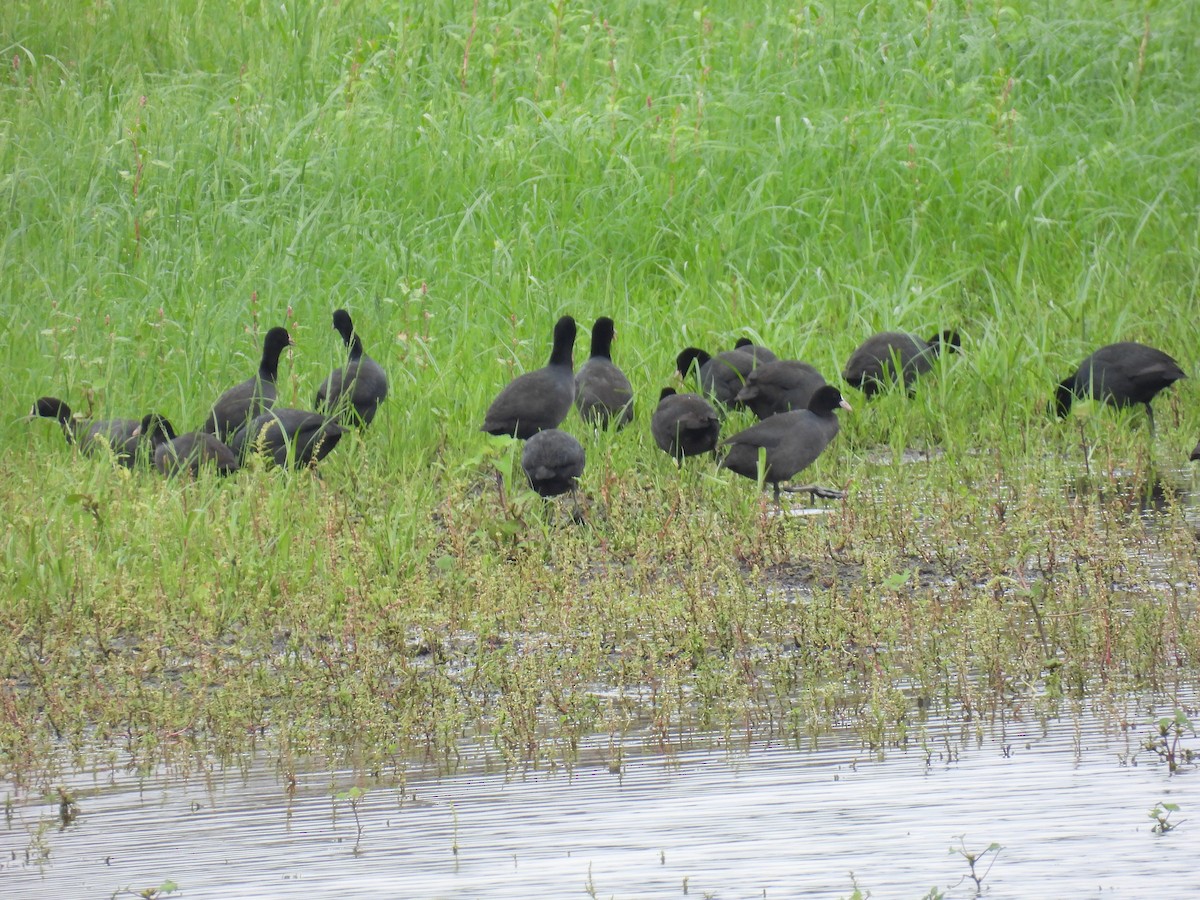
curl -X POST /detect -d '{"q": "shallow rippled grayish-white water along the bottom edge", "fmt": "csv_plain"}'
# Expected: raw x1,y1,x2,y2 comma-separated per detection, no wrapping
0,703,1200,898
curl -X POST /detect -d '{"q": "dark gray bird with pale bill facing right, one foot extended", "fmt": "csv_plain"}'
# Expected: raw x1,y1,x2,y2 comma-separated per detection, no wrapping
721,384,850,503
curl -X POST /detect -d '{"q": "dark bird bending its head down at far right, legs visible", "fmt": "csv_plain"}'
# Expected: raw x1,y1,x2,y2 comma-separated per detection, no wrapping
1055,341,1187,434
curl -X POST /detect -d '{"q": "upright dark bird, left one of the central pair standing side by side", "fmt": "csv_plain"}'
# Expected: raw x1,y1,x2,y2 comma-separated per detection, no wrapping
482,316,576,440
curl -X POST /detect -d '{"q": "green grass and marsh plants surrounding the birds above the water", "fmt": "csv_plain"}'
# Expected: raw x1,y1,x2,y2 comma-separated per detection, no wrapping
0,0,1200,787
